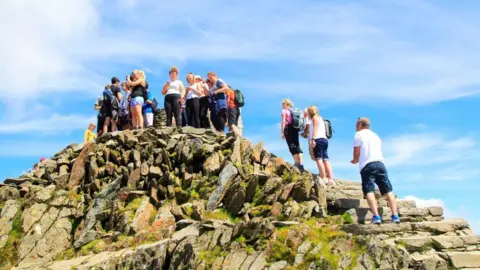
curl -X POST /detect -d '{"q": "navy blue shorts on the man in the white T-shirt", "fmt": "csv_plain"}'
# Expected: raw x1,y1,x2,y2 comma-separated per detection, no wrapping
360,161,392,196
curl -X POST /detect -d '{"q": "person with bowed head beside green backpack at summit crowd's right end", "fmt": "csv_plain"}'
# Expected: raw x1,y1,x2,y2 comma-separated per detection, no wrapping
207,71,228,132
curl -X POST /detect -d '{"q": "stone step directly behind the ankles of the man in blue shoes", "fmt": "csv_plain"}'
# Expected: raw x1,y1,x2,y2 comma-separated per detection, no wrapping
344,206,443,224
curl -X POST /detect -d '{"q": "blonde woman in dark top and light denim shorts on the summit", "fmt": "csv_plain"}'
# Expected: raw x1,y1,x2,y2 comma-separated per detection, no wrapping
127,69,148,129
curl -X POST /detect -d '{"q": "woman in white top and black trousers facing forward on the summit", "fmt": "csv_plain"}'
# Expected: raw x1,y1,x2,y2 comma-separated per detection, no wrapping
162,66,185,127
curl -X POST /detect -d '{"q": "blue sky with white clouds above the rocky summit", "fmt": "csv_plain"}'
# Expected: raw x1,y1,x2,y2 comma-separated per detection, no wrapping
0,0,480,232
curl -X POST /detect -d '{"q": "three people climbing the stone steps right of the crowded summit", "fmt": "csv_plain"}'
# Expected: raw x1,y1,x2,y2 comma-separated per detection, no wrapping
281,99,400,224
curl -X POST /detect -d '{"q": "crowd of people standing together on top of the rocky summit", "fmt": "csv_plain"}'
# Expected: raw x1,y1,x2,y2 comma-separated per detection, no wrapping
84,67,244,142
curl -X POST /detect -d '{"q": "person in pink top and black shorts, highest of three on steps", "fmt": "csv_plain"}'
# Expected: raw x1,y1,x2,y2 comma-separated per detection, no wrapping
281,99,304,170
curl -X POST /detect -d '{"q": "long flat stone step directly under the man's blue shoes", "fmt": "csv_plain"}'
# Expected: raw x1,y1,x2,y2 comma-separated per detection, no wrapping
342,219,468,235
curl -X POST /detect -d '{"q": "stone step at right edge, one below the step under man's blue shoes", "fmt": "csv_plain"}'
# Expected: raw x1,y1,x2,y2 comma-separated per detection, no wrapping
392,235,480,252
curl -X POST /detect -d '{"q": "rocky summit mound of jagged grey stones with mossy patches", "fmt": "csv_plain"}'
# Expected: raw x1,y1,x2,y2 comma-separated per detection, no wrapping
0,127,480,270
